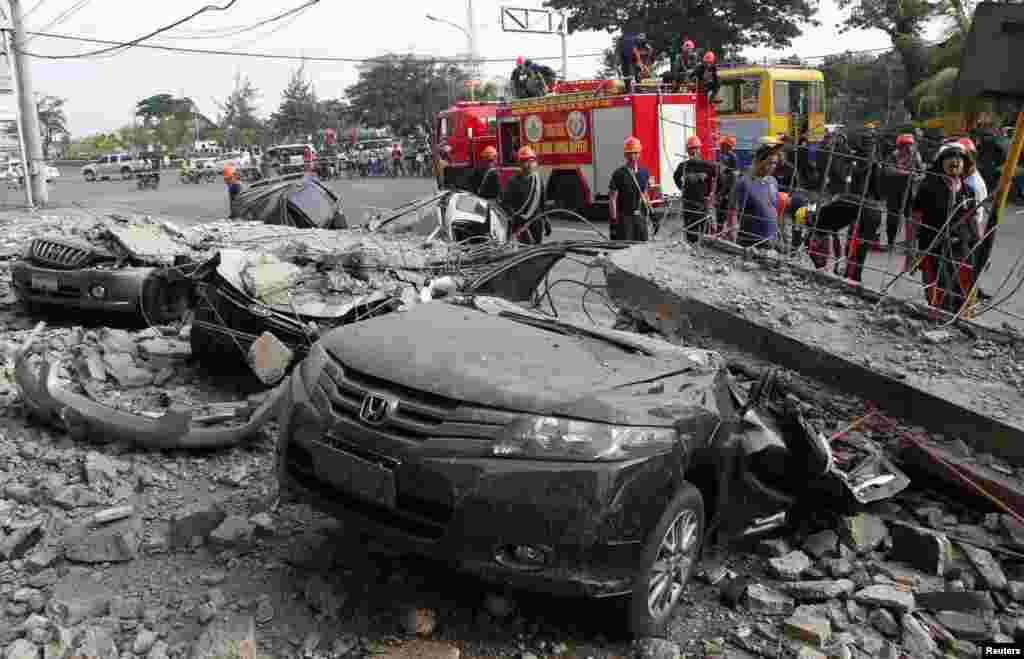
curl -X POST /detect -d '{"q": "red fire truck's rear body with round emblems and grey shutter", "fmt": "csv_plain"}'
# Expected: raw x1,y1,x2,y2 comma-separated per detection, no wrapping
491,80,718,220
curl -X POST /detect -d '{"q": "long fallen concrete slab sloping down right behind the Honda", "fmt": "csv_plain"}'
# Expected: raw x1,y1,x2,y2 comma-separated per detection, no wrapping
604,241,1024,465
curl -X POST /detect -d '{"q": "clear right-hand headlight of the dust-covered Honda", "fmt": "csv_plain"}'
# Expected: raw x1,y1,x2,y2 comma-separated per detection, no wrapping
492,416,677,460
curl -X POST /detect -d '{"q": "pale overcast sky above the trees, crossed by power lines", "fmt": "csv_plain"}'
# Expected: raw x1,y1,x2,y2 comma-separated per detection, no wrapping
4,0,942,137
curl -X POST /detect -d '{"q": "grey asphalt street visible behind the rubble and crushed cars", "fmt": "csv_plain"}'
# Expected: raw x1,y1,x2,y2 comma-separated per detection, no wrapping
9,169,1024,330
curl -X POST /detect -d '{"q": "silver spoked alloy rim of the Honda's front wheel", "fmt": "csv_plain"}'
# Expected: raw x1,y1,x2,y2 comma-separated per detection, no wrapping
647,511,698,618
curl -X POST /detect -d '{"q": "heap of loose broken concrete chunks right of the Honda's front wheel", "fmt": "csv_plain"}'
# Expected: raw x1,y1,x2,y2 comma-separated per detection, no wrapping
705,493,1024,659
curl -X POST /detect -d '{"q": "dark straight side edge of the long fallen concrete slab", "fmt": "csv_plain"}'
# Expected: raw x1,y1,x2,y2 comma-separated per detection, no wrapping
605,249,1024,467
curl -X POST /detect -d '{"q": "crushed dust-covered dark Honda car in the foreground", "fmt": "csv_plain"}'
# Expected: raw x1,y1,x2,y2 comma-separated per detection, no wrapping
278,296,908,634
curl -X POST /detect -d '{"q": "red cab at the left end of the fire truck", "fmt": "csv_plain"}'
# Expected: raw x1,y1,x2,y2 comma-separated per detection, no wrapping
434,101,498,187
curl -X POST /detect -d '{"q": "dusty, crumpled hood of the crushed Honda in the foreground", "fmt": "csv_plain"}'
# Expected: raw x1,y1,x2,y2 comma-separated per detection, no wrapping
323,302,724,426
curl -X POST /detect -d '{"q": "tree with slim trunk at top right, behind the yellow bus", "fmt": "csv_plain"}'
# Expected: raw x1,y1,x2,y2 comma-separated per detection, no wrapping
838,0,941,117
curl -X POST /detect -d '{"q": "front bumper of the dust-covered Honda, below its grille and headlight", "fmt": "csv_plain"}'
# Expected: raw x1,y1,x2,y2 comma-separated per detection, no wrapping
278,368,679,598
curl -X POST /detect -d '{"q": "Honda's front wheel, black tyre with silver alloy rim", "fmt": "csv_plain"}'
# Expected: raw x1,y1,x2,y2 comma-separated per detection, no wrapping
629,481,705,638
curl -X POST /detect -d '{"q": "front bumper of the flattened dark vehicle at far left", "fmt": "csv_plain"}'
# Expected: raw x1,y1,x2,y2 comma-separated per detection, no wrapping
10,261,149,313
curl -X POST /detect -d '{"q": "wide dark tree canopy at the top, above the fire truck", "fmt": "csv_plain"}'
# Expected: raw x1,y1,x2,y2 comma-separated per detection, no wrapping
545,0,815,67
